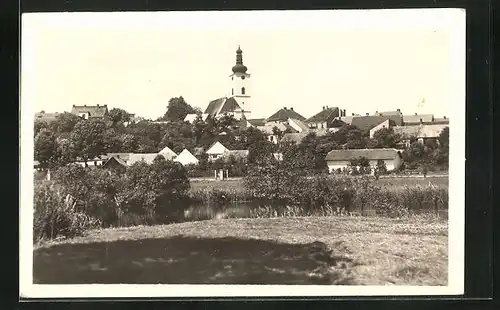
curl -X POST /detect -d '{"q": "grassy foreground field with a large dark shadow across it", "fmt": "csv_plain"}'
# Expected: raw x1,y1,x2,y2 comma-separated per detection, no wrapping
34,217,448,285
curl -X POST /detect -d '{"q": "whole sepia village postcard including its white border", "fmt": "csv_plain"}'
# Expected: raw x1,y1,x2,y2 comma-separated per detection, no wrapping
20,9,465,298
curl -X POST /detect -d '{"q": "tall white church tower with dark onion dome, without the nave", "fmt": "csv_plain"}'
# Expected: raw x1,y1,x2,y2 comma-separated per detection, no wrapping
229,46,252,118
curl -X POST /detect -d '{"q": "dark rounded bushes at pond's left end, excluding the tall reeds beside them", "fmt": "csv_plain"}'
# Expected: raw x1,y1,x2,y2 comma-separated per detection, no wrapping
43,156,190,232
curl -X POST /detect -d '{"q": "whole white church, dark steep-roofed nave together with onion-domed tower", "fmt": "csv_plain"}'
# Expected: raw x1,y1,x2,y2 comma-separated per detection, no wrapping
205,46,252,120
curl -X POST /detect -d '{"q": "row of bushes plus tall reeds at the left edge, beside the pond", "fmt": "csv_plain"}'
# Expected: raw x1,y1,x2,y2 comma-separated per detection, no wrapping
34,157,190,241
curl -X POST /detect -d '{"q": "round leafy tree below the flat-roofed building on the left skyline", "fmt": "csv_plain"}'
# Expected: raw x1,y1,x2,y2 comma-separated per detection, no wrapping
69,119,106,162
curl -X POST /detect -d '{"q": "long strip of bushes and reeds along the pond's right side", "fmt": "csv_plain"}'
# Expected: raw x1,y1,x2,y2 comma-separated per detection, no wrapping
244,162,448,217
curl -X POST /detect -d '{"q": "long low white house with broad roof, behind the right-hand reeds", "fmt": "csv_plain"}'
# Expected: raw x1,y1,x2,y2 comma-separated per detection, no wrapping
325,149,403,173
